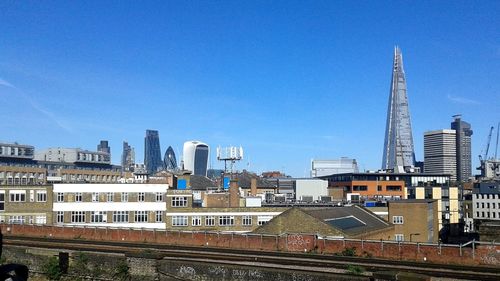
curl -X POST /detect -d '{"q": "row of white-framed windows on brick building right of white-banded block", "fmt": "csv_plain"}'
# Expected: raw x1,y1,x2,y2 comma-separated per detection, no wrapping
172,215,273,226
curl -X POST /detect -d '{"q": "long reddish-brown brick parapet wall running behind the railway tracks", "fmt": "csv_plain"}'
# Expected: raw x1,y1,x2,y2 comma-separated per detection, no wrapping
0,224,500,266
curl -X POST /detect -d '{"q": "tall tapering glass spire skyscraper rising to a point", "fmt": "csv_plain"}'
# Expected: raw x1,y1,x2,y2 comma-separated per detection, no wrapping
382,46,415,170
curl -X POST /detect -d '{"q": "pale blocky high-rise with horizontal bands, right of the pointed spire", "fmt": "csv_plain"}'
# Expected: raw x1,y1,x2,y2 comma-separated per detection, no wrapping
424,129,457,181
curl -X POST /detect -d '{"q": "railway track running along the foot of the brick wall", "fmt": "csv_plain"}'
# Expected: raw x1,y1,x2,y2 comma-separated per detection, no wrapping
4,235,500,280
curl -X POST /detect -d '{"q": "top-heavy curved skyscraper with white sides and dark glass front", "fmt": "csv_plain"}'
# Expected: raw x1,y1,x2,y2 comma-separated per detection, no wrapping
183,141,209,176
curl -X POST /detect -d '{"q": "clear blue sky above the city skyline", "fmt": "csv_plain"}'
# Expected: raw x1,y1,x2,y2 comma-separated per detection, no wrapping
0,0,500,176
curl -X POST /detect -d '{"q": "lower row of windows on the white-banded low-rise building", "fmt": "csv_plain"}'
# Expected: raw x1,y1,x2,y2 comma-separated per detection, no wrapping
56,211,163,224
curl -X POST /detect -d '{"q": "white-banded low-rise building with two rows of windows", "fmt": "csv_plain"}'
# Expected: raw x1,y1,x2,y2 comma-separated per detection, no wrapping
53,184,169,229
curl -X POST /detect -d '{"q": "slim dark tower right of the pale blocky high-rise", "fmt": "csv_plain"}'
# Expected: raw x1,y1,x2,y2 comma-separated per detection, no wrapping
451,115,472,182
